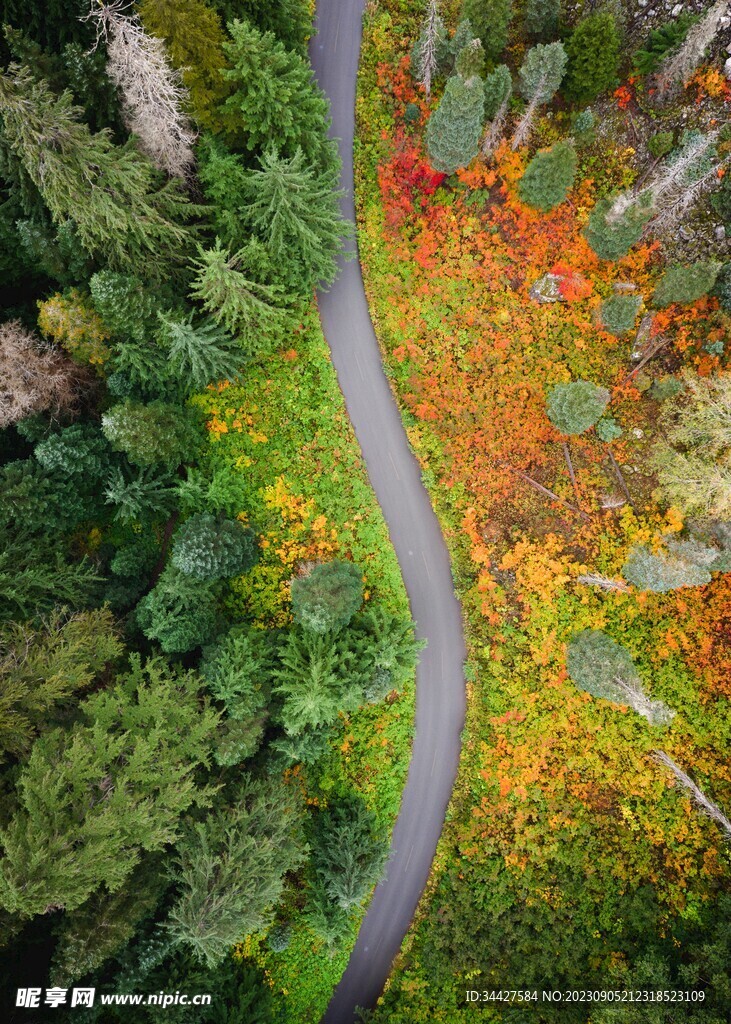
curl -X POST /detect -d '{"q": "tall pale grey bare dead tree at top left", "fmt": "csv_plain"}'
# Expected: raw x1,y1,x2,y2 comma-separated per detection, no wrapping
87,0,196,176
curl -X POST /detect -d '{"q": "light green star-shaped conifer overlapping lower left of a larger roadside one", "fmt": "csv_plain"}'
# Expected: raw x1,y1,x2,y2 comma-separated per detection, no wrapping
190,239,292,357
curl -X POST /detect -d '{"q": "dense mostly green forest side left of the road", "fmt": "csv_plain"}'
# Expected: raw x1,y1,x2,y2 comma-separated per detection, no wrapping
0,0,420,1024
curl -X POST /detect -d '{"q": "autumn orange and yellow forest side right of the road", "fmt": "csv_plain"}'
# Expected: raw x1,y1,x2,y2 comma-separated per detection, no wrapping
356,0,731,1024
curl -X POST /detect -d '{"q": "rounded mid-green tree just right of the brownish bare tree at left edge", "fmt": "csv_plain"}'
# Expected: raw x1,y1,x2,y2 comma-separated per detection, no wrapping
101,398,199,469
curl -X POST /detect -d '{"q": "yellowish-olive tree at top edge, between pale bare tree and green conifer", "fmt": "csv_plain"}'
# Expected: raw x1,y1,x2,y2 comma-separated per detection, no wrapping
139,0,228,131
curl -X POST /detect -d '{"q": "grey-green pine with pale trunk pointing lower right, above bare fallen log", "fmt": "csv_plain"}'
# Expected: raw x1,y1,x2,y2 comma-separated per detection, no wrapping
566,630,675,726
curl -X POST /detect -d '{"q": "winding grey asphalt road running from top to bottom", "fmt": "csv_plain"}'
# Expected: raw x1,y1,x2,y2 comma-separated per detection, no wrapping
310,0,465,1024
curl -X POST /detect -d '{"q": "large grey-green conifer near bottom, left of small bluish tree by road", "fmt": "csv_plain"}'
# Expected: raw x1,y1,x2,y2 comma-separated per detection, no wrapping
168,776,304,967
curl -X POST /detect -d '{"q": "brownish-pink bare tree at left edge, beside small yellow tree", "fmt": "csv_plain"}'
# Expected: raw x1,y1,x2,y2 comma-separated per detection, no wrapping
0,321,92,428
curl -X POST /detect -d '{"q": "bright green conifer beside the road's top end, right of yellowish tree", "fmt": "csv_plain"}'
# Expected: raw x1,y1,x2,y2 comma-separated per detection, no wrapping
220,18,330,166
